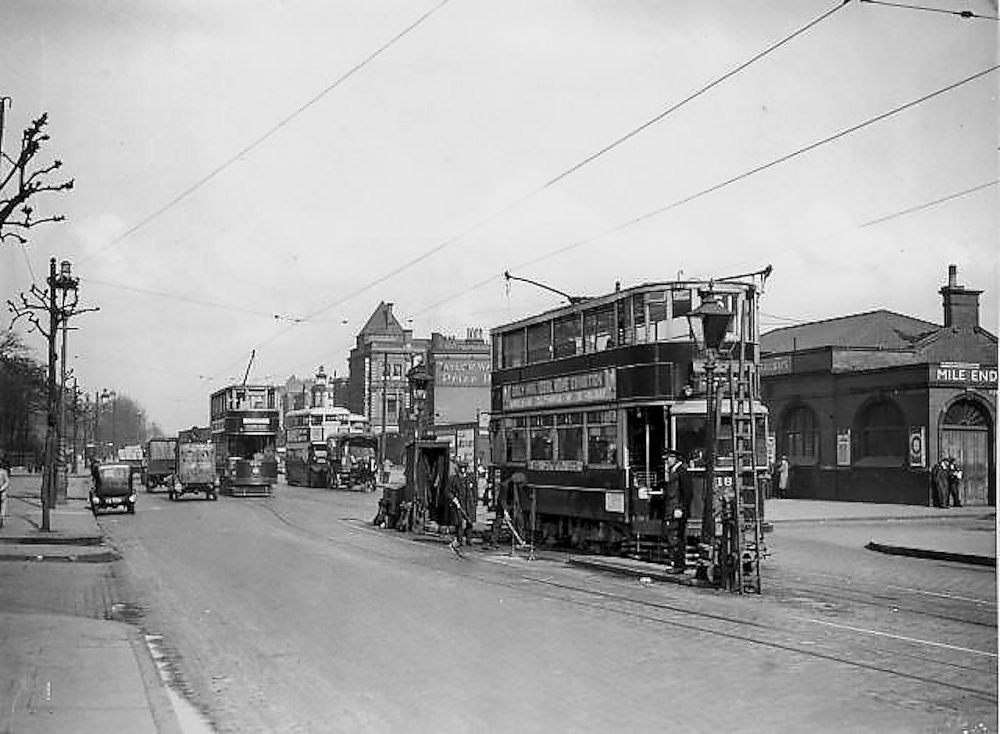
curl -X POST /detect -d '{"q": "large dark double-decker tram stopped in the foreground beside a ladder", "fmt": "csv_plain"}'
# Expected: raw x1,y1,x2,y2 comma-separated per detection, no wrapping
491,270,770,592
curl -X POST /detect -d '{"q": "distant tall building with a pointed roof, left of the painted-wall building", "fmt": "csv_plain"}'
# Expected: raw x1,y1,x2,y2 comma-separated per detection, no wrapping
347,301,429,462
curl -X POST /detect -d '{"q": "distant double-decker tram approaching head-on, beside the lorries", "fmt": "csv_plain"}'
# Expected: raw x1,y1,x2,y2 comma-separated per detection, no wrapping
209,385,278,496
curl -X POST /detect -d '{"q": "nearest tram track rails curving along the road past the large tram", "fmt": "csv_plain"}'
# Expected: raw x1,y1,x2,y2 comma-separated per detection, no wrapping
254,498,997,703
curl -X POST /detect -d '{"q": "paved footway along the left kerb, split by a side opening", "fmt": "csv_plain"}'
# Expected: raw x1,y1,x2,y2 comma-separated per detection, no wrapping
0,475,192,734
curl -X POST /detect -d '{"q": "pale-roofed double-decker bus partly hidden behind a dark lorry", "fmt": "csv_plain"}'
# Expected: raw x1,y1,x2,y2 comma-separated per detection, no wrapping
285,407,368,487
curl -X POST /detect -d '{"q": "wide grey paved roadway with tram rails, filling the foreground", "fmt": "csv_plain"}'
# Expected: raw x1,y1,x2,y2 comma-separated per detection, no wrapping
92,486,997,732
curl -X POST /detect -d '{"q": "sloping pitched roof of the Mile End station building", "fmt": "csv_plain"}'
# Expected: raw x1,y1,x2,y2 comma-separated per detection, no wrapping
760,309,942,353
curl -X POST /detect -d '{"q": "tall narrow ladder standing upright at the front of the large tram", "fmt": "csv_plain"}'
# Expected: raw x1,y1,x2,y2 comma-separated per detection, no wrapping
729,358,765,594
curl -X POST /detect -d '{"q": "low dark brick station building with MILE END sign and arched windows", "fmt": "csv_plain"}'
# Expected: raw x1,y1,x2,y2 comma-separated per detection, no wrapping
761,265,997,505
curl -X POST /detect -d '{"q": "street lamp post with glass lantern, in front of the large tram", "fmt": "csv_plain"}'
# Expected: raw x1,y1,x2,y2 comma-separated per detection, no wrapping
687,285,733,588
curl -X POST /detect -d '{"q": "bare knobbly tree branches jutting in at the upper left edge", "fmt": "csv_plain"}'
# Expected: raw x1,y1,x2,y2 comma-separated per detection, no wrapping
0,108,73,245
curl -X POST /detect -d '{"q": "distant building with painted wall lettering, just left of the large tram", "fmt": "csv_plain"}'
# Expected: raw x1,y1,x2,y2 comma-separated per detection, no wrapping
427,329,490,465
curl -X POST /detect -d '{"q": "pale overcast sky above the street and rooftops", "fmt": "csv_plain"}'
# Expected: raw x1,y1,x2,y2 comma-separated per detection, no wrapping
0,0,1000,432
